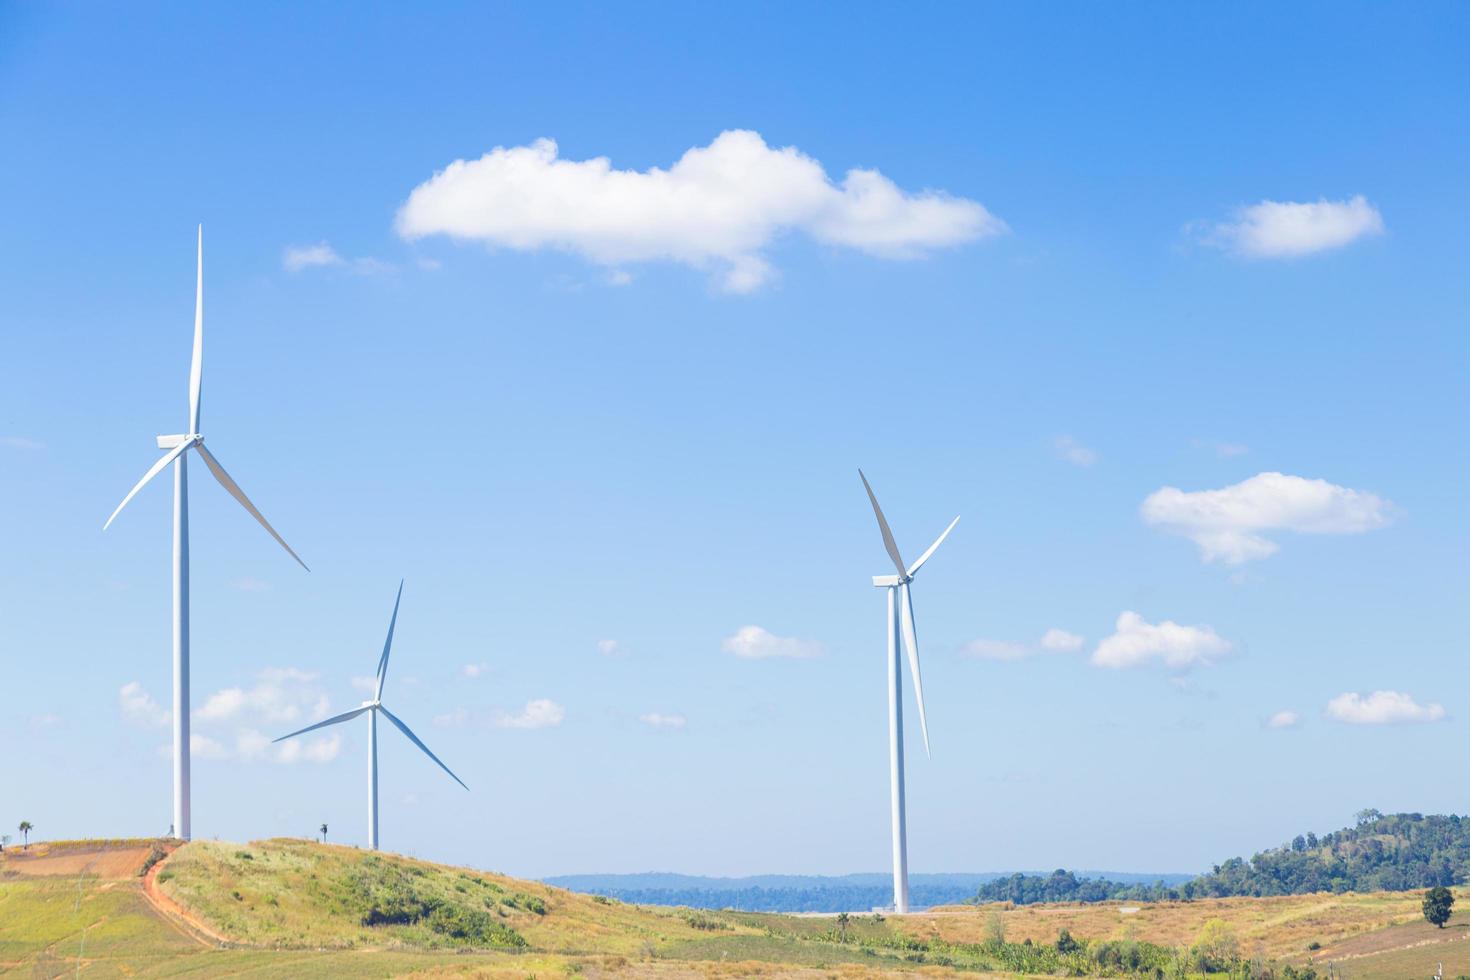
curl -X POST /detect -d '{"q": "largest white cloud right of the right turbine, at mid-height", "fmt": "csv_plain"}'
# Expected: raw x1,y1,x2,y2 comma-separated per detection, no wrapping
1139,473,1392,564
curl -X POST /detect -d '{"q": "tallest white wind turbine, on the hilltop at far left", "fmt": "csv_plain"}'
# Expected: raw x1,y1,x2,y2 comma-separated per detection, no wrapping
101,225,310,840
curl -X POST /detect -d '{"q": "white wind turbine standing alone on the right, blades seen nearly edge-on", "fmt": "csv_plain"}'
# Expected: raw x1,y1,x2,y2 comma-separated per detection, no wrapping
857,470,960,912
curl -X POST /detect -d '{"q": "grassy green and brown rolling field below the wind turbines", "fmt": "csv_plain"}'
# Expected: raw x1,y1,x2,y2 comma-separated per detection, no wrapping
0,840,1470,980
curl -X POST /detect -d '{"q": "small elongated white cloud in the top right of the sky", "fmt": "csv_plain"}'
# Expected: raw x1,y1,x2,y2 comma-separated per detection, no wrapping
1204,194,1383,259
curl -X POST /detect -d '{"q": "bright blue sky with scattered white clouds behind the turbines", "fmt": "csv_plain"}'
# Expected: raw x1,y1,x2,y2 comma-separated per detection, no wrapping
0,4,1470,874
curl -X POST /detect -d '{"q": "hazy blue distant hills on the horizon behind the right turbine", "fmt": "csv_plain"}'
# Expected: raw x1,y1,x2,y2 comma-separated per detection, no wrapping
545,871,1191,912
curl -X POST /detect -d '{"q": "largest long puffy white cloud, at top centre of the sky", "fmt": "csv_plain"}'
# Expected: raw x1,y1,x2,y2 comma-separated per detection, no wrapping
397,129,1005,292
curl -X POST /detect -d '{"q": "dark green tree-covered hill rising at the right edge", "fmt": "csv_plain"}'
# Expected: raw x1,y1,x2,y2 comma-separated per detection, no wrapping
970,810,1470,905
